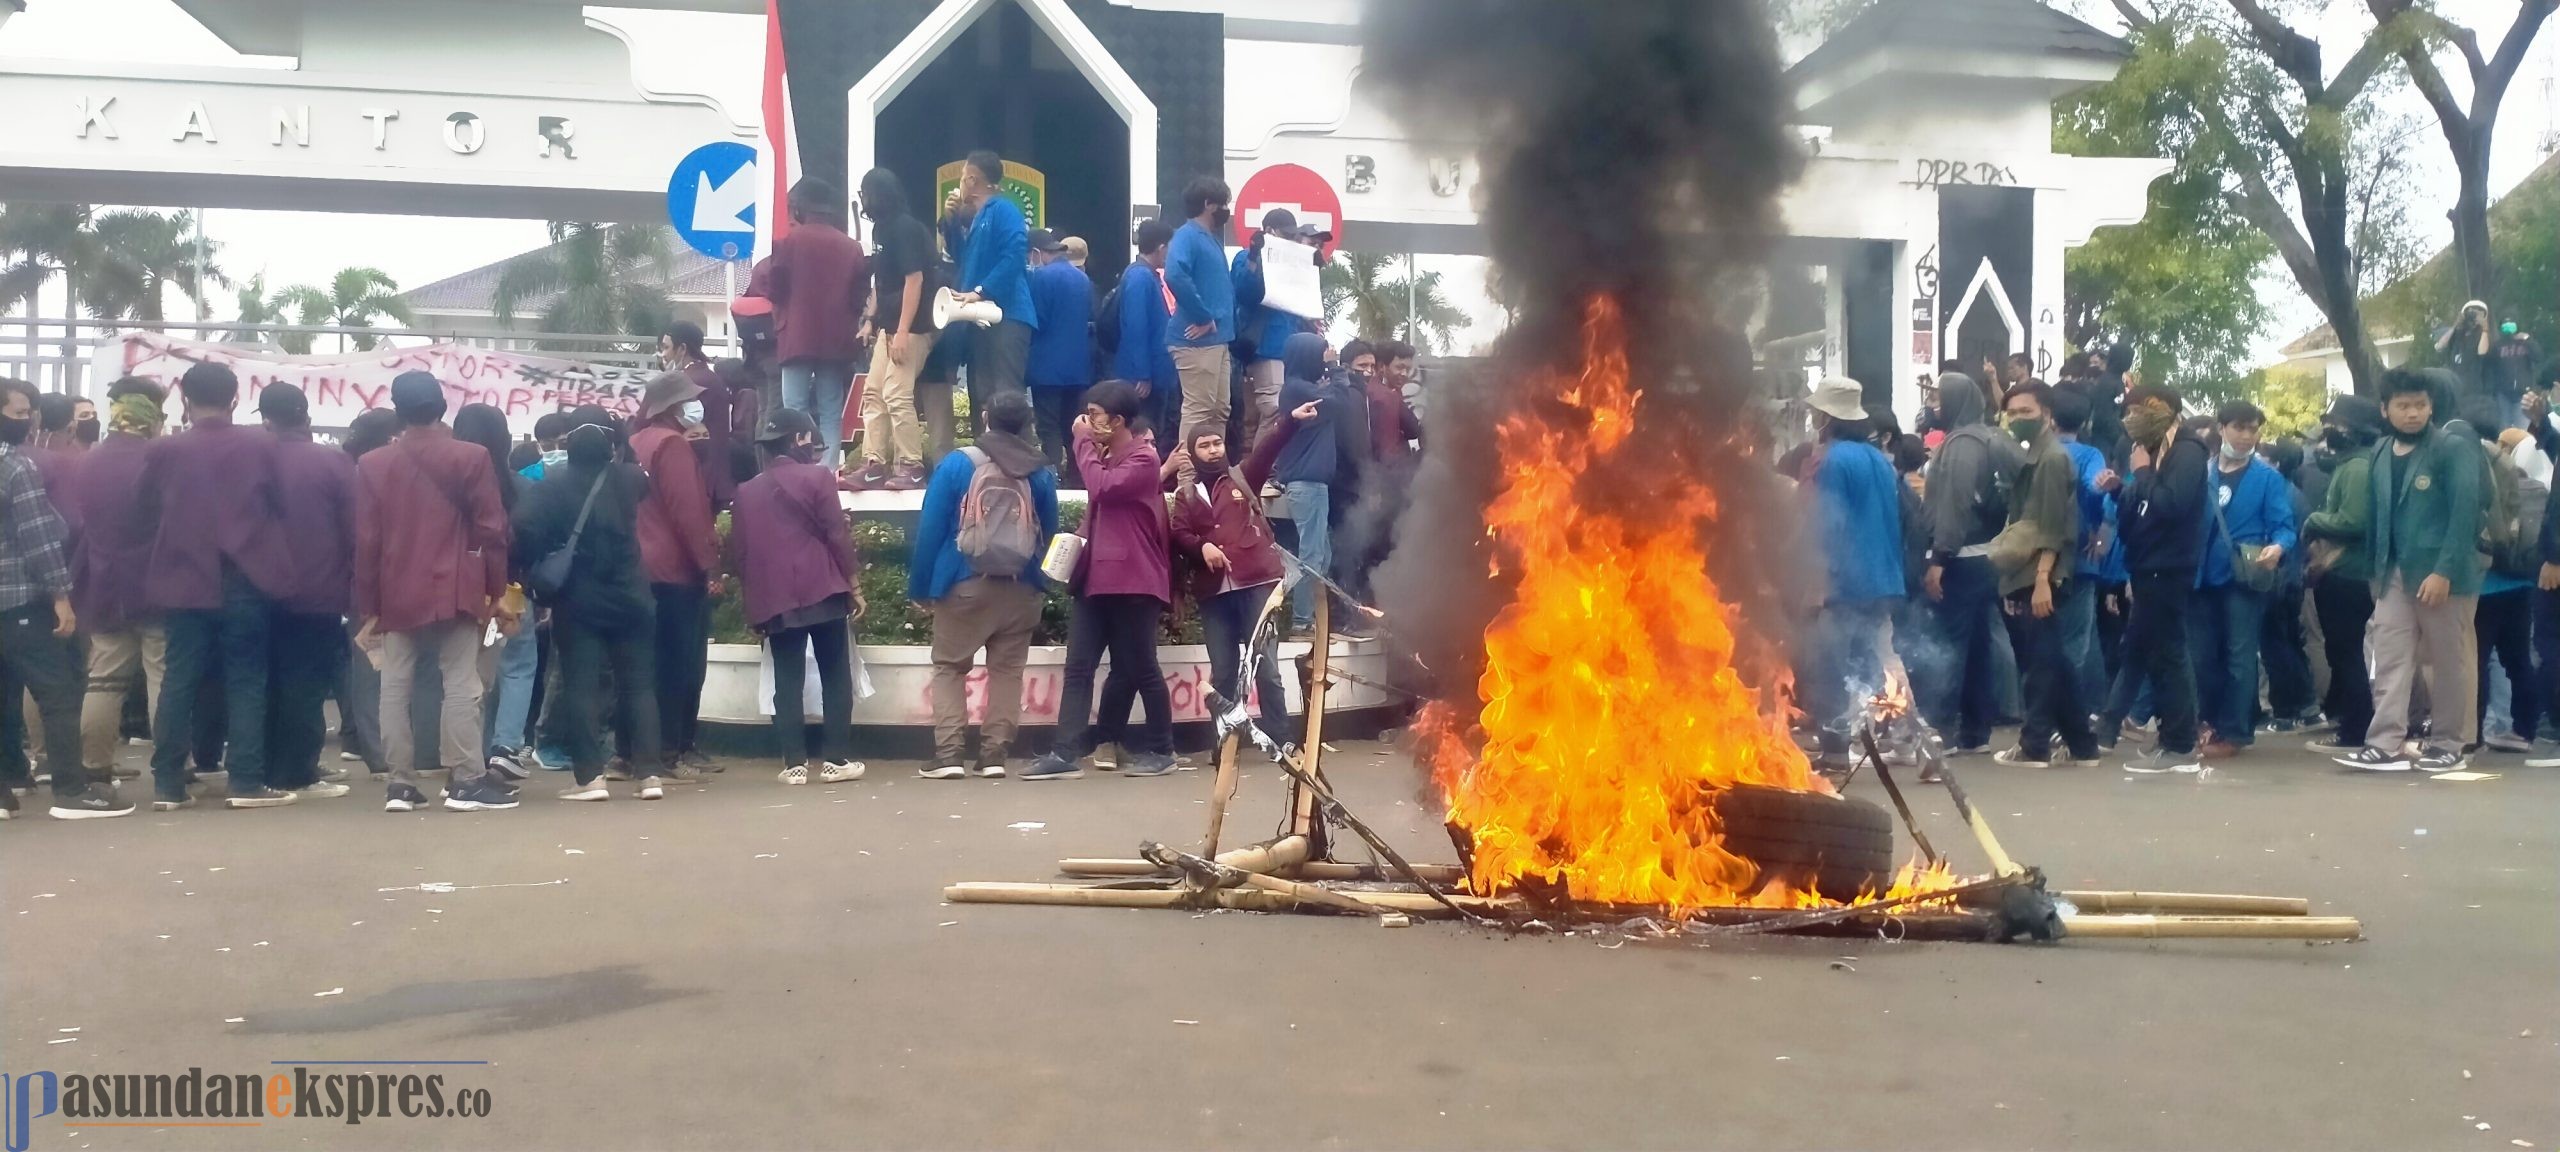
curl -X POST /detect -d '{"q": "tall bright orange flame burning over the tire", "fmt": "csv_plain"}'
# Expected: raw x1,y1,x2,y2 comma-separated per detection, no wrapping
1421,297,1830,911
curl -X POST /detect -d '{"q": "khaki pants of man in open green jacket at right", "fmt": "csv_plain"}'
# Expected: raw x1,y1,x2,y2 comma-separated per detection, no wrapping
2365,576,2481,753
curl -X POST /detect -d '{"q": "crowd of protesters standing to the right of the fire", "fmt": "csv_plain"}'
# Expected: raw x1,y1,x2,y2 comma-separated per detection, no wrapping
1782,305,2560,773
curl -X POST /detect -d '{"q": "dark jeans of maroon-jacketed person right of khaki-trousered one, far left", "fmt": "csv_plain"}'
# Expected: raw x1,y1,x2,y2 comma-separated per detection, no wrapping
153,563,274,799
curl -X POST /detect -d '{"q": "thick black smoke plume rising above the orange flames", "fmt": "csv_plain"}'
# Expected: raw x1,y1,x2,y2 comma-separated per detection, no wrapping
1362,0,1802,701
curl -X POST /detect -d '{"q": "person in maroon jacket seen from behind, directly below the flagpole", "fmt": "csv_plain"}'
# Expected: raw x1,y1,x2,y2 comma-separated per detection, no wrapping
730,410,863,783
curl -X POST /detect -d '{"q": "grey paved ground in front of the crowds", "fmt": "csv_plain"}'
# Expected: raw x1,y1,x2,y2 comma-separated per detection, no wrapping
0,745,2560,1149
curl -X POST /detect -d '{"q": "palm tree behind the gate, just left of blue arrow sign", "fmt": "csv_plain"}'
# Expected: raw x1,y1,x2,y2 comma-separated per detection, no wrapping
492,220,676,338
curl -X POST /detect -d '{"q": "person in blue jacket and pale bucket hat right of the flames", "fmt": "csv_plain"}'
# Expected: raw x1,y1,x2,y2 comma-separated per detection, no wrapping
1805,376,1902,771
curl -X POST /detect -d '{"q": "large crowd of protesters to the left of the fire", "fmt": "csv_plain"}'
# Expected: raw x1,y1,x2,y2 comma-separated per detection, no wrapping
0,154,1421,819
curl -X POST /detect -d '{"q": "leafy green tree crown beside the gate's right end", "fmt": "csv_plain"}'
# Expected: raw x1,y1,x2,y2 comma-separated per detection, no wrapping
2053,23,2276,394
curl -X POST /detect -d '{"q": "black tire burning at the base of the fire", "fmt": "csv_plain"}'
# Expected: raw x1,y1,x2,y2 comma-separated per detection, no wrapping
1715,783,1894,901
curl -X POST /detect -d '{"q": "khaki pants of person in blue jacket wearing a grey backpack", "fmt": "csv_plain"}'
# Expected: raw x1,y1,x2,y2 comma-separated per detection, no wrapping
932,576,1039,765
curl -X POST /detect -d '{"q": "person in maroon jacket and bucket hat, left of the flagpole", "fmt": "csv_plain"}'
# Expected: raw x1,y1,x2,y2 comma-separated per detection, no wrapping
632,371,719,783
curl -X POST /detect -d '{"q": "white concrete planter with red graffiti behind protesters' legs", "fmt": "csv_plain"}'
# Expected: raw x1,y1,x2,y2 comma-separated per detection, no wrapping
701,640,1393,727
